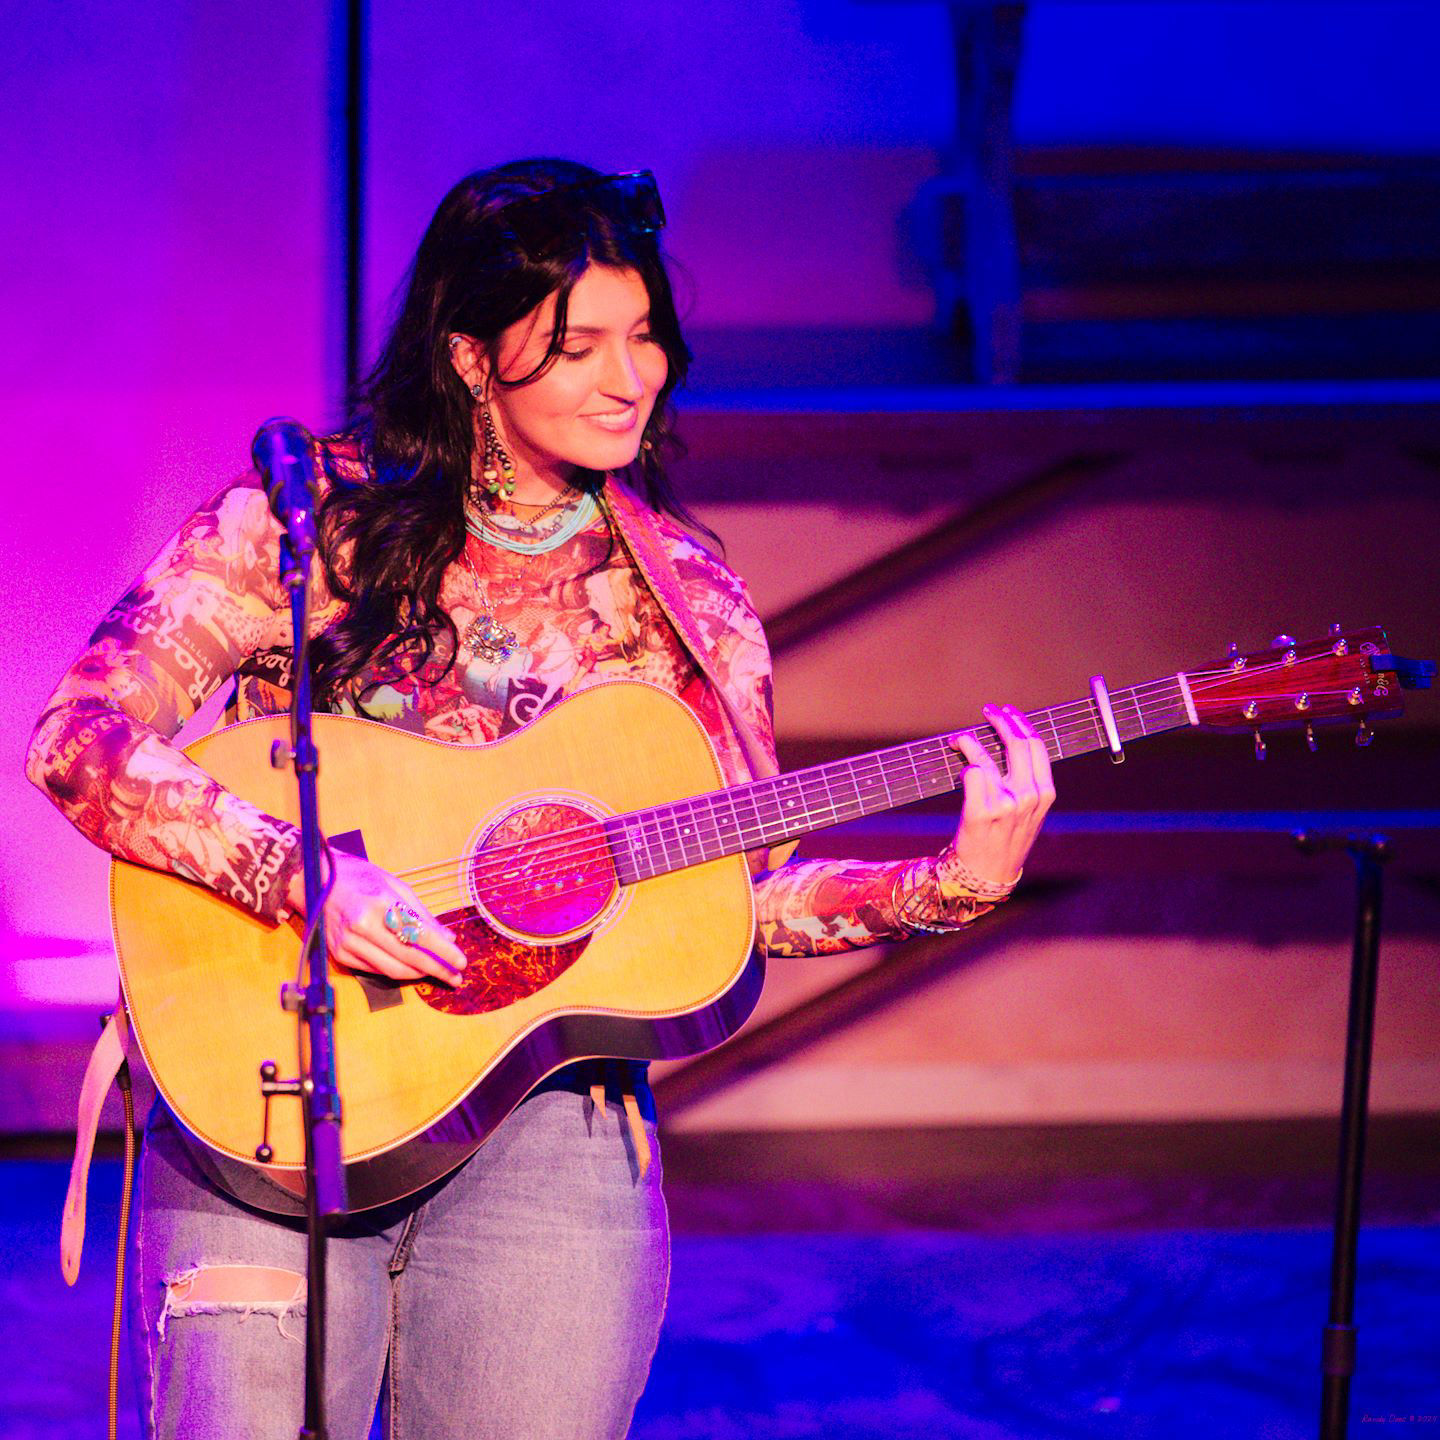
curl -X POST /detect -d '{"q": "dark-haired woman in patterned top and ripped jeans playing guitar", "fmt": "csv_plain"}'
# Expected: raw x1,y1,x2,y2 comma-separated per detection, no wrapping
29,160,1054,1440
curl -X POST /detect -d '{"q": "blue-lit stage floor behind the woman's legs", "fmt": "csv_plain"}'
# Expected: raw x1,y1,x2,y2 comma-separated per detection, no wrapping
0,1155,1440,1440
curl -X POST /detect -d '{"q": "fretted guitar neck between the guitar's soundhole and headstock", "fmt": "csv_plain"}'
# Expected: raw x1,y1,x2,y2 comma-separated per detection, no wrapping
605,675,1194,884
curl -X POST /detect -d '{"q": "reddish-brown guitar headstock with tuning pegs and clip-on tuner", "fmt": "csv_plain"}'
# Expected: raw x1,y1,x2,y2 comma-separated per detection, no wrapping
1185,625,1434,752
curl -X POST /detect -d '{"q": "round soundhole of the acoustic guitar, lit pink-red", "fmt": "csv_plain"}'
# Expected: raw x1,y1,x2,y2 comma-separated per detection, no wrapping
469,801,616,942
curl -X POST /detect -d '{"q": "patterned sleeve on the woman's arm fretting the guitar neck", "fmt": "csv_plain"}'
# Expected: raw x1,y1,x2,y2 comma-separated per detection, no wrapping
714,588,994,956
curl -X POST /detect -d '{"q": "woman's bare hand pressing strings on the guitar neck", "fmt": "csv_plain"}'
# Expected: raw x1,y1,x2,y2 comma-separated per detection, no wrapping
937,706,1056,887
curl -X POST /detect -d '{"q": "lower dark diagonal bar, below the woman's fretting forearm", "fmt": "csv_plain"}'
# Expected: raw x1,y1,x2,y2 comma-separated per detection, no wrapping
655,880,1083,1115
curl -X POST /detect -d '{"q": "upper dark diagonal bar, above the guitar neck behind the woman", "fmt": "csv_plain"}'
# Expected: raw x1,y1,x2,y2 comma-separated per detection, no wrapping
765,452,1126,655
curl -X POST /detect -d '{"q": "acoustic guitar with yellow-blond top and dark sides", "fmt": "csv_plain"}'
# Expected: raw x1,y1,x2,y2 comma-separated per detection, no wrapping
111,629,1416,1210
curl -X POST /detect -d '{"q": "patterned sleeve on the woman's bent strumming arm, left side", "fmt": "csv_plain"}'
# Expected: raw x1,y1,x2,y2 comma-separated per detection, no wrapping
26,477,309,919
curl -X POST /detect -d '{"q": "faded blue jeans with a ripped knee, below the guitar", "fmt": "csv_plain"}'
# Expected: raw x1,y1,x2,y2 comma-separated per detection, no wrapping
130,1089,670,1440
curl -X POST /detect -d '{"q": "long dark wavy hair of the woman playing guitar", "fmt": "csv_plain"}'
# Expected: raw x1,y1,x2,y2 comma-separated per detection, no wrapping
311,160,704,707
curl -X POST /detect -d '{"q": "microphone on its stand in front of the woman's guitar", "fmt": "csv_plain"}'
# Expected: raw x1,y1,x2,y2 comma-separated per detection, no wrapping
256,422,347,1440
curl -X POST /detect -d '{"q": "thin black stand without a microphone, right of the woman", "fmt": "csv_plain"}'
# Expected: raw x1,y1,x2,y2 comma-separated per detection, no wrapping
1295,834,1388,1440
